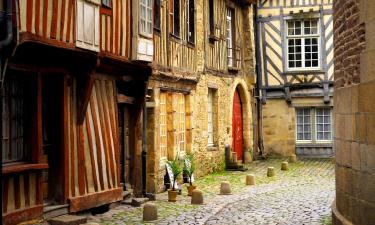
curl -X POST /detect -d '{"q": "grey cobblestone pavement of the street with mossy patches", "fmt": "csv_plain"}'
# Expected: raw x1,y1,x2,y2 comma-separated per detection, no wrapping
91,159,335,225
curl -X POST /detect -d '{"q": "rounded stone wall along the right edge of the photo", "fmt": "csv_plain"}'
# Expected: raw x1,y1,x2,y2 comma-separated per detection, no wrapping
333,0,375,225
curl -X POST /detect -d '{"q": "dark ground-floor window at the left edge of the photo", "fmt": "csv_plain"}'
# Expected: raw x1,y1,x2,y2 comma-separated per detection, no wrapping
1,77,30,163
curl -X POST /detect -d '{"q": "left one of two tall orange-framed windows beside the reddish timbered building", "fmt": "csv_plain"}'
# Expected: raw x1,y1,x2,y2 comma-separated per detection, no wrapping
160,92,168,158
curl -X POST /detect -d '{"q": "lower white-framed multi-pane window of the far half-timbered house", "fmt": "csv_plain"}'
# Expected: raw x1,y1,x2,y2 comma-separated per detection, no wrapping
296,108,332,143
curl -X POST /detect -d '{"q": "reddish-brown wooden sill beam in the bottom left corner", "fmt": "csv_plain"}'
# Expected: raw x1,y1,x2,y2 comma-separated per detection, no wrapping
2,205,43,225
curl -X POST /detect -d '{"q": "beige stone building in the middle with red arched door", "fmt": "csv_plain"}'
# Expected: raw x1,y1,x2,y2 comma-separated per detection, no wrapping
147,0,255,193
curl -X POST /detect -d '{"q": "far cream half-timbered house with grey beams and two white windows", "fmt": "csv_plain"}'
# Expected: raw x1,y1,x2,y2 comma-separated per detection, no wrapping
255,0,333,157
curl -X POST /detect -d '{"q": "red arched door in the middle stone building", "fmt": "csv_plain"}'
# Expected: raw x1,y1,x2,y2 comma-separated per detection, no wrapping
232,90,242,161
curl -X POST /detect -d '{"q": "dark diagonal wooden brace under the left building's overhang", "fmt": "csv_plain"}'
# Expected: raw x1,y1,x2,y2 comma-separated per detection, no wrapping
77,74,94,125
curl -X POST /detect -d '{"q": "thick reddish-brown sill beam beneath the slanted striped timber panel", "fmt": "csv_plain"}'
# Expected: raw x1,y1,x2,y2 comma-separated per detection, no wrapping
69,188,123,212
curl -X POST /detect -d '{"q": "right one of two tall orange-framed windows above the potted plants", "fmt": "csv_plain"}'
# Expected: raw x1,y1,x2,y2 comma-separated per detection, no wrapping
176,94,185,152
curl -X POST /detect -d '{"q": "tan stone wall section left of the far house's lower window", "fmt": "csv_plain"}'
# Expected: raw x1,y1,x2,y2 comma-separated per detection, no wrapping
262,99,296,156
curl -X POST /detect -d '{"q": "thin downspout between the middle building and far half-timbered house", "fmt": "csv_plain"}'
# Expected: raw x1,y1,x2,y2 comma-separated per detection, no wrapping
253,4,264,156
